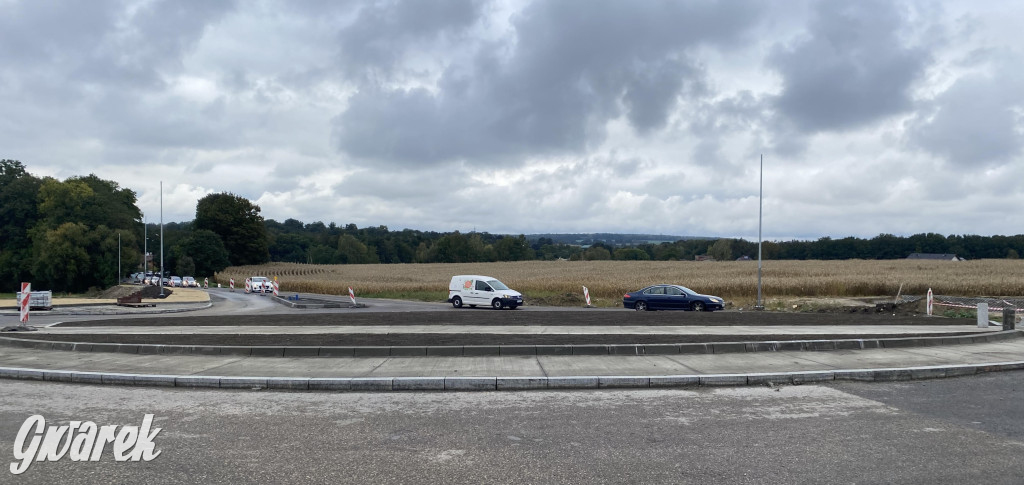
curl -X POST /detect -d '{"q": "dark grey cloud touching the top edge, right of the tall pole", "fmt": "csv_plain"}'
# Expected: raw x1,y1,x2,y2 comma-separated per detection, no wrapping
767,0,930,132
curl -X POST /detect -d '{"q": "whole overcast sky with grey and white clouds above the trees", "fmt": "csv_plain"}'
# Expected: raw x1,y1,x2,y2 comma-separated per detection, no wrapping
0,0,1024,239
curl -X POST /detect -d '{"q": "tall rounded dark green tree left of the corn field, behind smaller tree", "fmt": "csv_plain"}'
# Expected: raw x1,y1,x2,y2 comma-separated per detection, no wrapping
194,192,270,265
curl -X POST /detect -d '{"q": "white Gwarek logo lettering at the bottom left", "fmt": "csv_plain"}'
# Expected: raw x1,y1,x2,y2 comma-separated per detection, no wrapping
10,414,161,475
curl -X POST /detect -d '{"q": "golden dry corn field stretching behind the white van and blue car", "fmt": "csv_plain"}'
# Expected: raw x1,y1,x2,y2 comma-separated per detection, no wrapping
215,260,1024,302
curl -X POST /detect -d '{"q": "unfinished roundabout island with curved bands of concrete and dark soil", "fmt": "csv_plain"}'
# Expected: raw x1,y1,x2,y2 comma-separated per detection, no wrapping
0,292,1024,391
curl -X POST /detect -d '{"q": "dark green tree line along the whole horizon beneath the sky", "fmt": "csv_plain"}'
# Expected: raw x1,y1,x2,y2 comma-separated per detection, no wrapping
0,160,1024,292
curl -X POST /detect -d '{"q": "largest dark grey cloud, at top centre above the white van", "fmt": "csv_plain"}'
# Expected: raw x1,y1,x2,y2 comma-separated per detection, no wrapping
335,1,759,165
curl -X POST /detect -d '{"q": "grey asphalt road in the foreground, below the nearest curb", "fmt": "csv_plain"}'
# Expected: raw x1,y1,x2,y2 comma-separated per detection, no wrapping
0,372,1024,485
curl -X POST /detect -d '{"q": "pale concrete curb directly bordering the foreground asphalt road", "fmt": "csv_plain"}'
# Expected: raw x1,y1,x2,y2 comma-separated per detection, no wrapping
0,360,1024,392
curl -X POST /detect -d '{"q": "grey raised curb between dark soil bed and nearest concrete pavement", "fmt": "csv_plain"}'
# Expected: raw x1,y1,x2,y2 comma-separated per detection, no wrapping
0,329,1024,357
